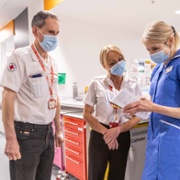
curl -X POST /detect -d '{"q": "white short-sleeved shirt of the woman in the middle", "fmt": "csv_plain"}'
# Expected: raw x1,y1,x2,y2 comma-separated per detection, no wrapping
83,76,142,125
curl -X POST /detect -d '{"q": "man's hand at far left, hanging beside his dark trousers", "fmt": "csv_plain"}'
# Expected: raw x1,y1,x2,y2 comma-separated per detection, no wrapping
5,139,21,161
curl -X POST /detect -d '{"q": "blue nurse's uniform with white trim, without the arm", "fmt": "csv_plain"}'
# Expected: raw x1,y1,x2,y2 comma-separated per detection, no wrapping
142,50,180,180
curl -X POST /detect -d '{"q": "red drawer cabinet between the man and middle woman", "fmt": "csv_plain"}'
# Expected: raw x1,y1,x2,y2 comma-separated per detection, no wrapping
63,115,87,180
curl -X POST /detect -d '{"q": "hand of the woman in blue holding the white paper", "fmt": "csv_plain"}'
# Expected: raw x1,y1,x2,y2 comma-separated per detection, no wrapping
123,98,154,114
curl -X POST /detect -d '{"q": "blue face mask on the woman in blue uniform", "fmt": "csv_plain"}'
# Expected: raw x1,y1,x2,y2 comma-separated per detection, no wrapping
150,50,170,64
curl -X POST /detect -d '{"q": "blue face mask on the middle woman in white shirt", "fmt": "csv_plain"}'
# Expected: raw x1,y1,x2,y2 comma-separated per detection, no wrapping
110,60,126,76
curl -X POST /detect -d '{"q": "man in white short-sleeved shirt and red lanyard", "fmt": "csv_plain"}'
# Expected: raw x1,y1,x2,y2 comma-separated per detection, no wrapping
1,11,63,180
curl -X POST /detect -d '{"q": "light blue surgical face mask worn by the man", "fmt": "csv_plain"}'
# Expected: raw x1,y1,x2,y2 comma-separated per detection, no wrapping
39,30,58,52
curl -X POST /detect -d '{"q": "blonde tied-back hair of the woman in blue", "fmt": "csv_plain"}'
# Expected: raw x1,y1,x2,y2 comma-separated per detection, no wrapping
142,21,180,49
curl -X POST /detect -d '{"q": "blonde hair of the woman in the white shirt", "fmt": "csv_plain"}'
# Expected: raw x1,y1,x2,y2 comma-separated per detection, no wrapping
99,45,125,66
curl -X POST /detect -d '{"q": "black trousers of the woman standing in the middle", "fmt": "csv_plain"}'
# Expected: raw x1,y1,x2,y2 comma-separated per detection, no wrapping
88,126,130,180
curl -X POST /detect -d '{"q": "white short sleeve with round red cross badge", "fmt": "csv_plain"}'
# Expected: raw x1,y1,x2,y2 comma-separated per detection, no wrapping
0,53,25,92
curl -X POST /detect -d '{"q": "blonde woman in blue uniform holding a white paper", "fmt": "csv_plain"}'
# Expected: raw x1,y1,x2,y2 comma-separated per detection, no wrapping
124,21,180,180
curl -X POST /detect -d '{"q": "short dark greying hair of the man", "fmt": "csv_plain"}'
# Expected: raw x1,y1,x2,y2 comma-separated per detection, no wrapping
31,11,59,28
